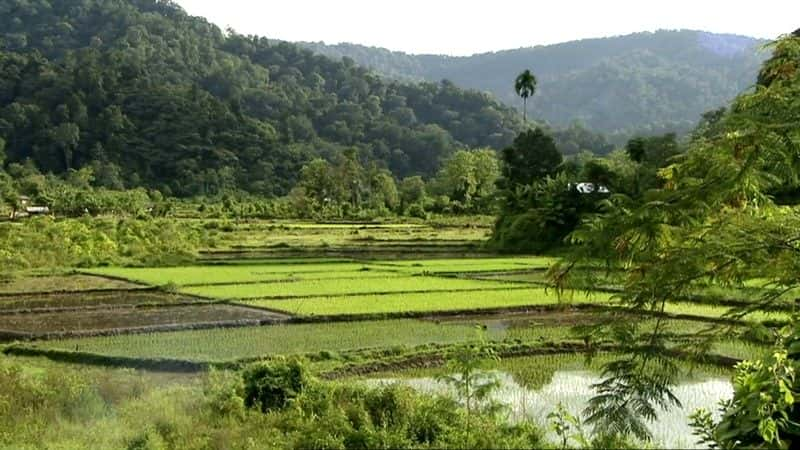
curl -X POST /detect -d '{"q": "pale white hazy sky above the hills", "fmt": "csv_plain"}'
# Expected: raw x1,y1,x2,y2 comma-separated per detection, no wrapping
177,0,800,55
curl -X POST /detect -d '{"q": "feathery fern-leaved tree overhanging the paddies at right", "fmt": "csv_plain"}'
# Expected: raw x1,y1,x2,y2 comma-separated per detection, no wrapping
550,30,800,439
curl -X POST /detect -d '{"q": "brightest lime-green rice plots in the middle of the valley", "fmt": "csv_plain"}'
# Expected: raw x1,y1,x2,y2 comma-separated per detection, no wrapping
81,256,789,321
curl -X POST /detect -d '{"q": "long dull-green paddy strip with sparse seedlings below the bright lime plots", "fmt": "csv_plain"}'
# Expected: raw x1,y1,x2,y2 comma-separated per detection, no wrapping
35,313,758,362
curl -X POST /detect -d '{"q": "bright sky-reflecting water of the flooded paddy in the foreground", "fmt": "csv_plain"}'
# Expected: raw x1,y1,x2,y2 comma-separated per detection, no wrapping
366,370,733,448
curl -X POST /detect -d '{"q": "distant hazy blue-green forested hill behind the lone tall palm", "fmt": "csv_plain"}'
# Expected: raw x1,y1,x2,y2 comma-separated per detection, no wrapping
303,30,767,141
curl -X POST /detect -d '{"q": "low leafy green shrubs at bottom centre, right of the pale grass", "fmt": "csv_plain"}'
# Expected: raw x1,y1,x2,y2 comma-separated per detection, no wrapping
282,385,544,448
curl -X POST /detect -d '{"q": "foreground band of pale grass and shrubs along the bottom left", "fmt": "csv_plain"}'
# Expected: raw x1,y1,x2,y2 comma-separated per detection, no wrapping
0,358,545,449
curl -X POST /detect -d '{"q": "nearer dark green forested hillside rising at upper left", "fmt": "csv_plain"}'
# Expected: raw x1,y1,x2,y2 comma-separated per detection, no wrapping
0,0,522,196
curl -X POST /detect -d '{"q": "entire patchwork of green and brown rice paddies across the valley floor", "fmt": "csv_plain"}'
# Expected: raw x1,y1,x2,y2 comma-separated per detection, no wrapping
0,220,791,446
